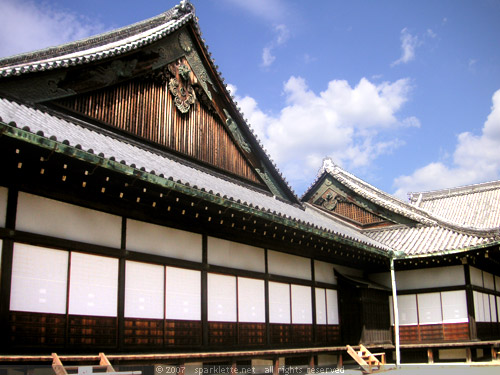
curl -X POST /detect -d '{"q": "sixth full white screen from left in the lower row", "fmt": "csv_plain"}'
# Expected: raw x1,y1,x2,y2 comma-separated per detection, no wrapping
238,277,266,323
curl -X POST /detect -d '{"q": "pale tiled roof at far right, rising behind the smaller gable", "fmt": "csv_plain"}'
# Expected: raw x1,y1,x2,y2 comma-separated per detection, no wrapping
408,181,500,229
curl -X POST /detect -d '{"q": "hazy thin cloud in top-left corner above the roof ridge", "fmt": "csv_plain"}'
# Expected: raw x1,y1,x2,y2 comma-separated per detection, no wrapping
0,0,104,56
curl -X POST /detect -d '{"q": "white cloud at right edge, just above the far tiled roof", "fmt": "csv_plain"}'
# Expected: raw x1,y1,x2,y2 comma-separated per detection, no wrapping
394,90,500,198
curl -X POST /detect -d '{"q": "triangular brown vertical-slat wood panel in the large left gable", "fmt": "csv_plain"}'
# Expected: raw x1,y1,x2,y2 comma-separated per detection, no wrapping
56,78,259,182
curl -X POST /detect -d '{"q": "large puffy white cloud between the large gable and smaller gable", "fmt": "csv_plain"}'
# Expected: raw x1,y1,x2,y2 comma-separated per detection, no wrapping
233,77,418,194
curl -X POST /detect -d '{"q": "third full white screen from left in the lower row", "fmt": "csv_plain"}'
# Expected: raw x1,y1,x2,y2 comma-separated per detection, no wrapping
125,261,165,319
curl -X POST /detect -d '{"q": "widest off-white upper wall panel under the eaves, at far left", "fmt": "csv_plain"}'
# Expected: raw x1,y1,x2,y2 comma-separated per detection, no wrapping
16,193,122,248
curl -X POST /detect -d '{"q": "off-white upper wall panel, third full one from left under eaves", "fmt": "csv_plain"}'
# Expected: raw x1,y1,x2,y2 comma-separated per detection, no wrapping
208,237,266,272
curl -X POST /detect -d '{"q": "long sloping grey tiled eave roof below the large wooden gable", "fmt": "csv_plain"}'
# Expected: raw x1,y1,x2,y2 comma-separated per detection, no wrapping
0,98,390,252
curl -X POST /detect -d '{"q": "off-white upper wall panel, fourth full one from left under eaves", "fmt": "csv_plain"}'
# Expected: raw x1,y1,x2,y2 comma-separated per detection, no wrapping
267,250,311,280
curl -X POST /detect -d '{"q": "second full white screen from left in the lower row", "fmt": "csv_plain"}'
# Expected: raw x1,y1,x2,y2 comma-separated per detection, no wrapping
69,252,118,317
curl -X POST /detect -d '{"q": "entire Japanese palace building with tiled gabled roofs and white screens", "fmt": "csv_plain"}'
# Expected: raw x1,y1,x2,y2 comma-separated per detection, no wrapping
0,1,500,366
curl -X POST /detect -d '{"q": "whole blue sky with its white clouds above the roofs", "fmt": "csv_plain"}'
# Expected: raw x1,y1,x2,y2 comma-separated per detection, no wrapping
0,0,500,199
